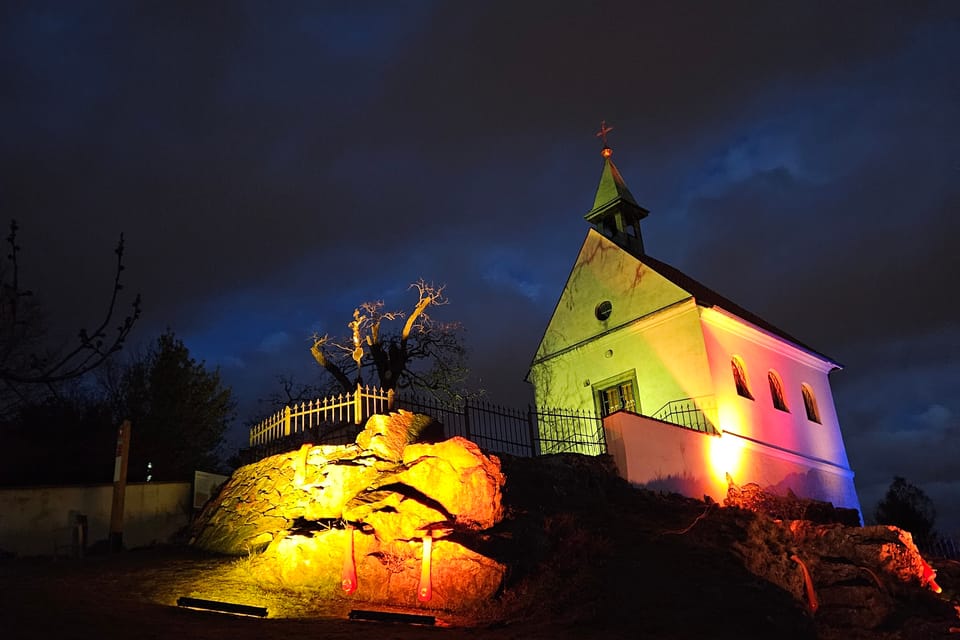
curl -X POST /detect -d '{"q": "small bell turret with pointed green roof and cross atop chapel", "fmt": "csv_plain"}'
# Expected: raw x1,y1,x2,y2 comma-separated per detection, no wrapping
584,121,650,254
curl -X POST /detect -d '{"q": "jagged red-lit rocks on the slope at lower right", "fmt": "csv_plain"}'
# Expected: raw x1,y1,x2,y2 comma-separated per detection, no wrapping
725,484,952,638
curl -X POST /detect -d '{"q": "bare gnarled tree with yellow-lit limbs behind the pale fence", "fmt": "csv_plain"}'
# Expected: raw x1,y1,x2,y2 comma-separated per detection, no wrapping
310,280,468,400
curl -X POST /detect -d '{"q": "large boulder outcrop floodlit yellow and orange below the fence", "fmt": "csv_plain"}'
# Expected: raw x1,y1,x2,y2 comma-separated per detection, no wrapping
192,411,505,610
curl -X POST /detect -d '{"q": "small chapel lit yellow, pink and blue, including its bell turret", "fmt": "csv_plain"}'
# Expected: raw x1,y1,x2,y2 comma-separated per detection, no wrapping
527,132,860,510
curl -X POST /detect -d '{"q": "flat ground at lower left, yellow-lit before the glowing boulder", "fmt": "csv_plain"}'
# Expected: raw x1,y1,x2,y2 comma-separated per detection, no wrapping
0,548,488,640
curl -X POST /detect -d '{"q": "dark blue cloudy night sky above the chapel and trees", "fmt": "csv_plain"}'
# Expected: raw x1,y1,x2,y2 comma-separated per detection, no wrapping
0,0,960,534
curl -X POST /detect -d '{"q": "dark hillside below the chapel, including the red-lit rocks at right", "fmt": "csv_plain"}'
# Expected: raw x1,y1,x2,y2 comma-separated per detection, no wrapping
494,455,960,640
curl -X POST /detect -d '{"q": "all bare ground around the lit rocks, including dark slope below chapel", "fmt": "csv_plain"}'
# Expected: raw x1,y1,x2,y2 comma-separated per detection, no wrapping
0,452,960,640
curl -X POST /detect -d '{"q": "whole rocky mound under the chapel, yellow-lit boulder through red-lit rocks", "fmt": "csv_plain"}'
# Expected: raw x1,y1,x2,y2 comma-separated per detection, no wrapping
188,414,960,640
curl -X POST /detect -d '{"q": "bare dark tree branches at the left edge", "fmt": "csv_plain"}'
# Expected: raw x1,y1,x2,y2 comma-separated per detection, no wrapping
0,220,140,410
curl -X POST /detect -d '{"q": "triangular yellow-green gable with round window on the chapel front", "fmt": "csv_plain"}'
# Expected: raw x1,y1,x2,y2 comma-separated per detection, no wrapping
535,229,691,362
